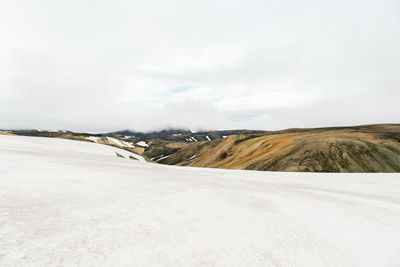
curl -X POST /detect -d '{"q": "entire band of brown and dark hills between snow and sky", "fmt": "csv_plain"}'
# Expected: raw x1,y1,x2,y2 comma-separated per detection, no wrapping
3,124,400,172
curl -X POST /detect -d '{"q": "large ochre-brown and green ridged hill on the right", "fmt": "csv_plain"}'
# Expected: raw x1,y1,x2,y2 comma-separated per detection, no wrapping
152,124,400,172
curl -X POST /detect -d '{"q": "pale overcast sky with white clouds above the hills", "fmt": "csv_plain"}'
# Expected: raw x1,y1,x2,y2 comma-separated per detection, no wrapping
0,0,400,132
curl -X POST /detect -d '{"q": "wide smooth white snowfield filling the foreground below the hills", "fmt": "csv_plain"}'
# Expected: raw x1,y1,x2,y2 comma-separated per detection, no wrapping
0,136,400,266
